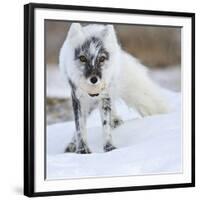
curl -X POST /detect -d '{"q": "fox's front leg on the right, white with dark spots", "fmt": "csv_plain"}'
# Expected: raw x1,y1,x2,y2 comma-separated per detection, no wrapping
100,96,116,152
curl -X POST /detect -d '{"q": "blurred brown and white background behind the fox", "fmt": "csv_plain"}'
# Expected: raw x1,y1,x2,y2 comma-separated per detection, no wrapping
45,20,181,124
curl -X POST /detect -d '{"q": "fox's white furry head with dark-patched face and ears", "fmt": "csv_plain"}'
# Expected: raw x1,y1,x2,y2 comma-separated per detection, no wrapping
60,23,120,97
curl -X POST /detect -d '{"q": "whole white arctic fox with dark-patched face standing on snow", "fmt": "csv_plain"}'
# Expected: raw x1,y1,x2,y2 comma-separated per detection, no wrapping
59,23,169,153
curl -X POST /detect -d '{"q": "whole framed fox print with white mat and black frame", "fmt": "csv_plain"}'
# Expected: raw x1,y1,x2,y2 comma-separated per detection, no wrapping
24,3,195,197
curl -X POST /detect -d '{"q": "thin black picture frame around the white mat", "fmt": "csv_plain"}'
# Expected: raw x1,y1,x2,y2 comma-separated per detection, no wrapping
24,3,195,197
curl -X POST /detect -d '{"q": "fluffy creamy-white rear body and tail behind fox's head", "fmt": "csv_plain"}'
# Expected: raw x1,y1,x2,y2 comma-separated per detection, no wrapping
118,51,169,116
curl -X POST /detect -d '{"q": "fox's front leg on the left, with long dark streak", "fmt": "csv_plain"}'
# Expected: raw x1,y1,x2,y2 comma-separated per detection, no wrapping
66,92,91,154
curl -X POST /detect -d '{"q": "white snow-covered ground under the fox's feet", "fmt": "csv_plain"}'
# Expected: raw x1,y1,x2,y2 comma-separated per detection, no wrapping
46,91,182,179
